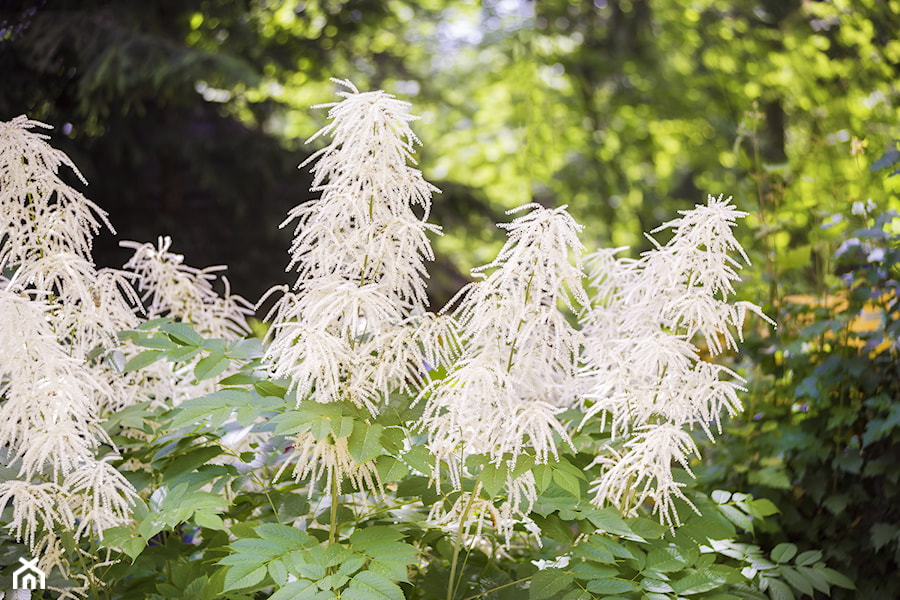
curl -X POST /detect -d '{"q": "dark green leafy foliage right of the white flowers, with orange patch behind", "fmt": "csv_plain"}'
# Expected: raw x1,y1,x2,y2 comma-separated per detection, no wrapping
710,165,900,597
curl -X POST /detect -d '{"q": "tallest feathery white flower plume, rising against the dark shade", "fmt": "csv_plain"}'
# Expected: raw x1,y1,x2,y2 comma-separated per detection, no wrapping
264,80,455,488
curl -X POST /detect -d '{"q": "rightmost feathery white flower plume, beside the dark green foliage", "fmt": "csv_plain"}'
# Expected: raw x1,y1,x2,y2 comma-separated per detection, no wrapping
581,196,768,526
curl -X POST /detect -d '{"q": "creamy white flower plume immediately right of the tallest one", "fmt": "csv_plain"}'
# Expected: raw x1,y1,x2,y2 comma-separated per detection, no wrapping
423,204,587,486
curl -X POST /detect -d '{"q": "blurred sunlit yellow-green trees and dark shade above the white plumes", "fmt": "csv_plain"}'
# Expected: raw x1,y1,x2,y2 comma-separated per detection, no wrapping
0,0,900,302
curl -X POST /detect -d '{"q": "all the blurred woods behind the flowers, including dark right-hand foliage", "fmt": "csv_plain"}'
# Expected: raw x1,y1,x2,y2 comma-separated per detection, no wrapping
0,0,900,598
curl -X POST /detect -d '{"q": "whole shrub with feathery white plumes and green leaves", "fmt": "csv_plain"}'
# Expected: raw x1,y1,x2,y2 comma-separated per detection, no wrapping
0,81,852,600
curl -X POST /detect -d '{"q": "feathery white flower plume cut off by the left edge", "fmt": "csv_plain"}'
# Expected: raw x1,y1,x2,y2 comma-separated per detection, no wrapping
0,116,138,572
